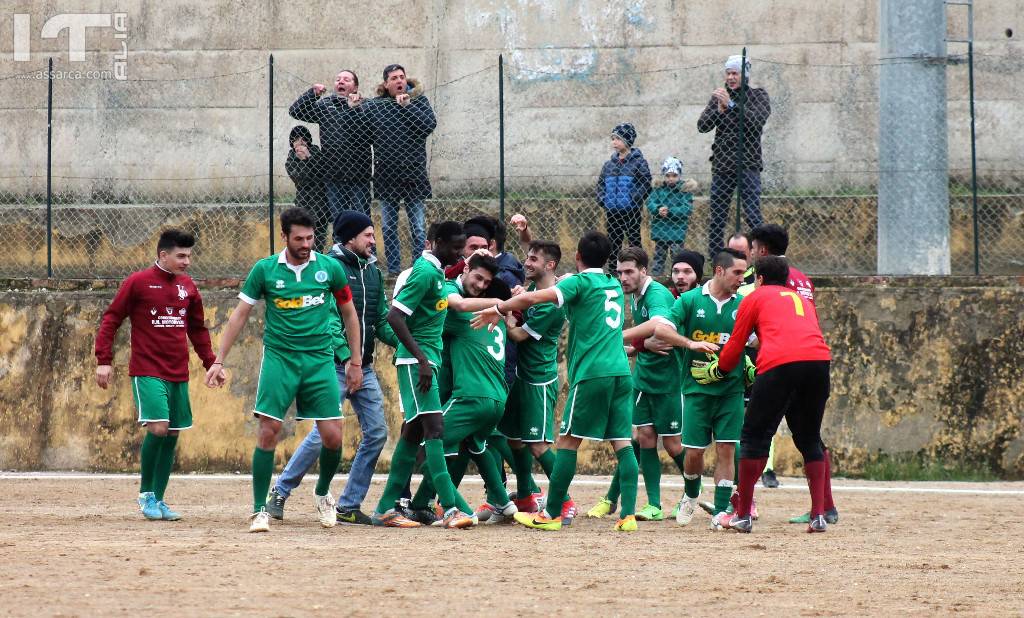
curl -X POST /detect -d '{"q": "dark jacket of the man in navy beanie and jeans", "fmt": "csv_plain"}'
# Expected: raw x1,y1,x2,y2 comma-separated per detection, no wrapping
328,245,398,367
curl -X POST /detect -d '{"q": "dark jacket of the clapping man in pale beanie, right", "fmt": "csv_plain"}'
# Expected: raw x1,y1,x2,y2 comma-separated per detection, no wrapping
697,86,771,174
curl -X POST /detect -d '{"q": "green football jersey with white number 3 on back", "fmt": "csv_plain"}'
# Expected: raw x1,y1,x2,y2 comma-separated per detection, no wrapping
444,276,508,401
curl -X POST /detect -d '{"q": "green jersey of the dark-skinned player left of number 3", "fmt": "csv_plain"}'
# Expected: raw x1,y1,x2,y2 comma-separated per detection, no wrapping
391,251,447,365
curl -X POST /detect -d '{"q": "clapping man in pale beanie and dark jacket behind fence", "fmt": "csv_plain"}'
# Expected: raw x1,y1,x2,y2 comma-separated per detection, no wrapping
697,56,771,256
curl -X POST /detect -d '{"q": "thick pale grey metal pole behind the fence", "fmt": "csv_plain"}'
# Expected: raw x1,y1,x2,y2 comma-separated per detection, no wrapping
878,0,950,275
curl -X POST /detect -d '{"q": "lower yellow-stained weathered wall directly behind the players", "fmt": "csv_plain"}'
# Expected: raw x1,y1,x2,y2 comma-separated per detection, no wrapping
0,277,1024,478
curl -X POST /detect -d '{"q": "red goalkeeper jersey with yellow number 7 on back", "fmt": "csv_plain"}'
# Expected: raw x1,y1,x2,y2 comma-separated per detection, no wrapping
718,284,831,373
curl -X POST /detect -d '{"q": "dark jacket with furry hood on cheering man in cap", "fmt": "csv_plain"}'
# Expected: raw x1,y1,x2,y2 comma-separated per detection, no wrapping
369,79,437,202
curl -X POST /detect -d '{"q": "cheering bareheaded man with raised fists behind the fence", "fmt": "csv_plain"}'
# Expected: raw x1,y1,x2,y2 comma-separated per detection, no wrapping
288,70,373,220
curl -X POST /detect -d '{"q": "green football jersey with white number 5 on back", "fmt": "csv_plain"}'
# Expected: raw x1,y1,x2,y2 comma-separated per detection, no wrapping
555,268,630,387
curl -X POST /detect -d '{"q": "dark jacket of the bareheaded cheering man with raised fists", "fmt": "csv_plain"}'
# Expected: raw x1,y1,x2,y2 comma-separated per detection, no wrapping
288,88,373,182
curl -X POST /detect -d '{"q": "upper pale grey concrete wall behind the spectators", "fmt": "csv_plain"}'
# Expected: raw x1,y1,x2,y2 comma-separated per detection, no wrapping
0,0,1024,200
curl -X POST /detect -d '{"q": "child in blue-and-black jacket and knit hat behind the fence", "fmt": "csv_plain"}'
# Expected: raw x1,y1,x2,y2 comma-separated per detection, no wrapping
597,124,650,268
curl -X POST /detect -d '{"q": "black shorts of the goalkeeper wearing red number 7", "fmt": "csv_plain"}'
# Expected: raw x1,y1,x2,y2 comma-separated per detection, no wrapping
740,360,831,461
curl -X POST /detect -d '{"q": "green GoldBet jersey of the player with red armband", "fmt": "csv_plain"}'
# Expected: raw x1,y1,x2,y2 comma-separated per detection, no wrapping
239,250,348,352
